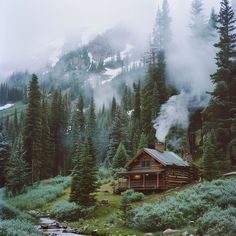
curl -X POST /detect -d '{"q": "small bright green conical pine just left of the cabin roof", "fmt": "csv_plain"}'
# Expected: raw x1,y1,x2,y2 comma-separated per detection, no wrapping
112,143,130,169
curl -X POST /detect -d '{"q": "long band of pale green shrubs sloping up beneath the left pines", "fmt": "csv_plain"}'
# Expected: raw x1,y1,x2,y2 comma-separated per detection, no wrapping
9,176,71,210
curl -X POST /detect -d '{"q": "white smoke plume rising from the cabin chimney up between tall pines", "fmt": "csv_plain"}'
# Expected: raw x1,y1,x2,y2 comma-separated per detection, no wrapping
154,0,218,142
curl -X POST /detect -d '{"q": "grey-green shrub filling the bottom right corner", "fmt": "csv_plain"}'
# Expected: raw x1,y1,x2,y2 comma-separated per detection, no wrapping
197,207,236,236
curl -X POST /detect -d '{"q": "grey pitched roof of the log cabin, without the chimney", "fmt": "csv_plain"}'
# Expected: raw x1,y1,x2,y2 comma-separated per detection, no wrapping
125,148,190,167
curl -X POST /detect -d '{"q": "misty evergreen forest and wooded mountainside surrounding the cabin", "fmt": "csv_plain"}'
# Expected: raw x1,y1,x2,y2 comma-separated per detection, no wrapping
0,0,236,218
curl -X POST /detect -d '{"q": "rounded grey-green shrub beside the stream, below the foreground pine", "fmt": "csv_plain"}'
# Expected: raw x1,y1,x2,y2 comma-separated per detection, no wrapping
49,200,81,220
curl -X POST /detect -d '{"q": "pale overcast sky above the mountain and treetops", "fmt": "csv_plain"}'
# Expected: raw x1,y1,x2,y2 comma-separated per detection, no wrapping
0,0,220,75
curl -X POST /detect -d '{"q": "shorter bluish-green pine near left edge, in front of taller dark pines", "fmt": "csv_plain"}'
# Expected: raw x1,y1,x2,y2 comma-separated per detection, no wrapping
5,135,29,195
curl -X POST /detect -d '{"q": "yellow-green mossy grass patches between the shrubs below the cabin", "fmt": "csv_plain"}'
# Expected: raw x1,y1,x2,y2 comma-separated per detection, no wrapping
42,184,196,236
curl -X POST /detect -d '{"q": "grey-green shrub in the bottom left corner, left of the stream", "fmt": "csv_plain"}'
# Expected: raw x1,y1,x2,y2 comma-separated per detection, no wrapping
0,219,42,236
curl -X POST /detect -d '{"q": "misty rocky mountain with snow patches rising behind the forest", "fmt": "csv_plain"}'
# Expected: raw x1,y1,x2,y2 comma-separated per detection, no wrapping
39,27,144,106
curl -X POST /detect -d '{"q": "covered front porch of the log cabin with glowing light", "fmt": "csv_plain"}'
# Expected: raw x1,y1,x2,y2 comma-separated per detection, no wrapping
117,170,163,192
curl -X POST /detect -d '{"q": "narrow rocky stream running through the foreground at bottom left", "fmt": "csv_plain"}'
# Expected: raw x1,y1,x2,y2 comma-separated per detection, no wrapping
37,217,83,236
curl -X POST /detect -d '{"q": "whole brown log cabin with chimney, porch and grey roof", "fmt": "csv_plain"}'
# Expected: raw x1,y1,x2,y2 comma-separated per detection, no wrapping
116,144,199,193
